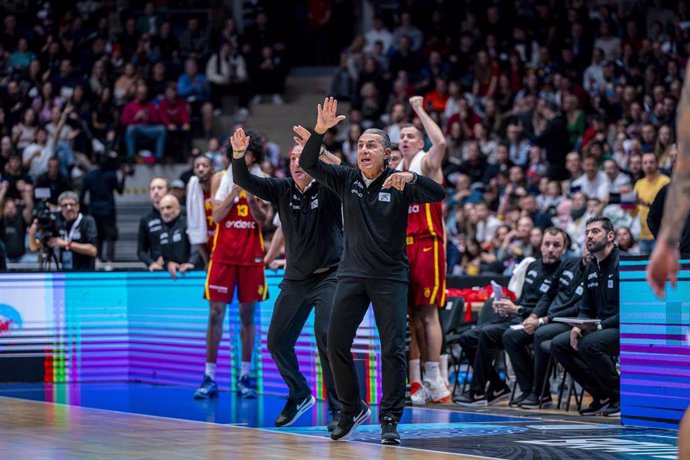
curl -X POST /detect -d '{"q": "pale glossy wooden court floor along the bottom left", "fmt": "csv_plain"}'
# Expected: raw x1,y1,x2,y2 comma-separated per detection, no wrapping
0,397,481,460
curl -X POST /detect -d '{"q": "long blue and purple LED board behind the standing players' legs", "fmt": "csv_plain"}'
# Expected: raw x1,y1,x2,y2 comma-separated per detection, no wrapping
0,270,381,402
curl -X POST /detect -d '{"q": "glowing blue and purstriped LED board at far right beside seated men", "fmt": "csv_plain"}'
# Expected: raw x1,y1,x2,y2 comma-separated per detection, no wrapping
620,260,690,428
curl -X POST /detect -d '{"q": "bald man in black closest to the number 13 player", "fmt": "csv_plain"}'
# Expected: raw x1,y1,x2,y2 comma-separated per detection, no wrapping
159,195,202,279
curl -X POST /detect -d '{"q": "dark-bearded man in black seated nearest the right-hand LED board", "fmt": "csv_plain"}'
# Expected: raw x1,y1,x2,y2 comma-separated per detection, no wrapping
551,217,620,416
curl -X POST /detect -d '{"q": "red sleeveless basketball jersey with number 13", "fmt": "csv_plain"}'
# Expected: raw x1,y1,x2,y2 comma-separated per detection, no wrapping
211,191,264,265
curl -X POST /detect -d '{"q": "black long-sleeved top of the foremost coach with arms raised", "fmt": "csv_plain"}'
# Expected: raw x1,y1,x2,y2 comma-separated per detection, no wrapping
300,134,445,282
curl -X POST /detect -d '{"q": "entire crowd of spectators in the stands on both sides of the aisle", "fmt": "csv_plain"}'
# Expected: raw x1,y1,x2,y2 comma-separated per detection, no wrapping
0,0,690,275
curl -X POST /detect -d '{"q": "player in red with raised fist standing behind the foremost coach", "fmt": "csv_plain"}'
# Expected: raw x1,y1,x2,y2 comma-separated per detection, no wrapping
399,96,451,404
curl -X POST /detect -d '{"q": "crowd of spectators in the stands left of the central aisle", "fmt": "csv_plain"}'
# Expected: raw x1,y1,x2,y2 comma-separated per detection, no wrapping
0,0,287,268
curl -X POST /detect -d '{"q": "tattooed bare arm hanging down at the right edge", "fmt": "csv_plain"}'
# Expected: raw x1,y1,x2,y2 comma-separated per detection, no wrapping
647,63,690,298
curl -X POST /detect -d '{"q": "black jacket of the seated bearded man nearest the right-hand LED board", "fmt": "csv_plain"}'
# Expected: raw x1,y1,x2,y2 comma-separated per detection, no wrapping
578,246,620,329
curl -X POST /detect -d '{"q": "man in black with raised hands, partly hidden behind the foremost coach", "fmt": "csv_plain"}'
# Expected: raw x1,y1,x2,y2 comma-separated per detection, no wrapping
230,127,343,431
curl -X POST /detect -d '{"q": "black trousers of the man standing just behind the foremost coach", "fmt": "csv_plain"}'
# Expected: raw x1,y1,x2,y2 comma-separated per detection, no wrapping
268,269,341,412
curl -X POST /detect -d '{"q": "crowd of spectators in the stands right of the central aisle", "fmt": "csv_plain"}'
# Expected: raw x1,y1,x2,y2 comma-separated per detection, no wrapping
327,0,690,275
